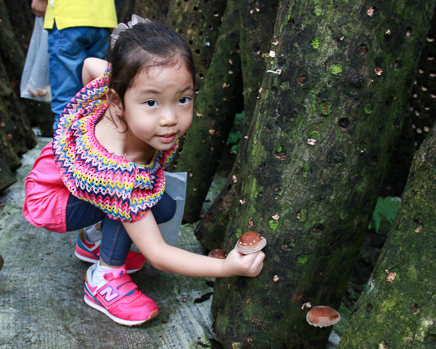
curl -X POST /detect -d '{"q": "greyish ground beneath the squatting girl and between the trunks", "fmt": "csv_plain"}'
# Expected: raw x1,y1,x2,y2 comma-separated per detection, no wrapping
0,131,388,349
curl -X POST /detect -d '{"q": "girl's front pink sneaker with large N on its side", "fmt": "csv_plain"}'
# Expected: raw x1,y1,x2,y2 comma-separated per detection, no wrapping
84,264,159,326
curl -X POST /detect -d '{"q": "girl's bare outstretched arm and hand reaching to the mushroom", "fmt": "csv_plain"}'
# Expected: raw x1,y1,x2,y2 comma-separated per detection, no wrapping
123,211,265,277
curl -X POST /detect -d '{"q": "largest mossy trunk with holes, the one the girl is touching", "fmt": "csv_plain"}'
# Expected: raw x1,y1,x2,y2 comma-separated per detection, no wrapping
212,0,434,348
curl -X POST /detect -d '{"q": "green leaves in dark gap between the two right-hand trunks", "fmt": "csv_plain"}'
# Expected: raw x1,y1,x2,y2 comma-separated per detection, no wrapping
369,196,401,233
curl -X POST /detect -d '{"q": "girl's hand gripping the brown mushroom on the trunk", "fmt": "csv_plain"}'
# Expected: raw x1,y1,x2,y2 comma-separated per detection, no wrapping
224,250,265,277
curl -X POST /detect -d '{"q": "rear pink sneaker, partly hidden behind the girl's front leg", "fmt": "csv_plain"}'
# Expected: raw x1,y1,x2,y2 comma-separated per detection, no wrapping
74,229,147,274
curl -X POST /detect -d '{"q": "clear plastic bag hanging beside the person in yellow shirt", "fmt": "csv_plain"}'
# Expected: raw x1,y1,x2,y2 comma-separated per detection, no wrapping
20,17,51,102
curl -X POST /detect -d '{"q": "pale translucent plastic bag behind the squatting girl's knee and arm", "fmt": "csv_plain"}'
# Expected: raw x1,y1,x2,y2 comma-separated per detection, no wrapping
159,171,188,246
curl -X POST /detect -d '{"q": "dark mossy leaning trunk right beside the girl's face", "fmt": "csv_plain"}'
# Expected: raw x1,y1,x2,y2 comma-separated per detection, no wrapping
171,1,243,223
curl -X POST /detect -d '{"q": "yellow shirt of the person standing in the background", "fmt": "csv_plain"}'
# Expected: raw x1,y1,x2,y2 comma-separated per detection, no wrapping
44,0,117,30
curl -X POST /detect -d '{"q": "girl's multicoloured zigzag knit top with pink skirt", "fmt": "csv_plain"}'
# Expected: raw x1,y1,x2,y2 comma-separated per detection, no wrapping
23,68,178,233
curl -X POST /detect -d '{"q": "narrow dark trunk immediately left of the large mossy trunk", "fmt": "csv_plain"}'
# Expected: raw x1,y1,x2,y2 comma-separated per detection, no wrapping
195,0,278,250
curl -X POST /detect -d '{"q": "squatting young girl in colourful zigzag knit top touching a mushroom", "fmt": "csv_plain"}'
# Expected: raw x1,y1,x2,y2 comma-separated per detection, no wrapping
23,19,265,326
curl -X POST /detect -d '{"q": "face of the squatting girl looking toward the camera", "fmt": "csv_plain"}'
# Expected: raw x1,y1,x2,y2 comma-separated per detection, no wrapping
115,60,194,153
